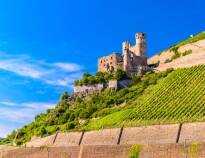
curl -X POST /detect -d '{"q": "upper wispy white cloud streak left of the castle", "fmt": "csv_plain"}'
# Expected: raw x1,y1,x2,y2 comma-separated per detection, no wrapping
0,52,83,87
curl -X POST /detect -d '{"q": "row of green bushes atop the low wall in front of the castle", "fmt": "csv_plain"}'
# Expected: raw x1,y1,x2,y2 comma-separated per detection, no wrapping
75,69,126,86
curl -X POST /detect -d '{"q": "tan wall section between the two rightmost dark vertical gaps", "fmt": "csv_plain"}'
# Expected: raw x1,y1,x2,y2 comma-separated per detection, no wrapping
120,124,179,144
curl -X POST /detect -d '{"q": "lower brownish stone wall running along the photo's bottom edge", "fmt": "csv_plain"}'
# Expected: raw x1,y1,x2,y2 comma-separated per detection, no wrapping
0,144,205,158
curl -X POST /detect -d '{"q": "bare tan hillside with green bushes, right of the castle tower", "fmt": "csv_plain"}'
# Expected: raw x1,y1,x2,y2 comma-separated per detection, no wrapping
148,32,205,67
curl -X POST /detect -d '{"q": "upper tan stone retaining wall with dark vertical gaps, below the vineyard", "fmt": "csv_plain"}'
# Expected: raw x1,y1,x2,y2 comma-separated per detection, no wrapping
26,122,205,147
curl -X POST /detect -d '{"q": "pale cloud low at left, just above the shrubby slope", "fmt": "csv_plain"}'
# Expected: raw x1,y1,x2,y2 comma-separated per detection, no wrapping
0,101,56,137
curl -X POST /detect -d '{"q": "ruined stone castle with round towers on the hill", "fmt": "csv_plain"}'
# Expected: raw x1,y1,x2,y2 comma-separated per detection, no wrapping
98,32,147,77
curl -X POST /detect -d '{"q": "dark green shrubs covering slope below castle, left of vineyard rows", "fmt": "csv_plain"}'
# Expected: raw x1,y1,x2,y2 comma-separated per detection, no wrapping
0,70,171,144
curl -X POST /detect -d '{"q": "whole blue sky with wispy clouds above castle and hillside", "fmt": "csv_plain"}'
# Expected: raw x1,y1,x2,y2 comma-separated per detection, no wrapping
0,0,205,137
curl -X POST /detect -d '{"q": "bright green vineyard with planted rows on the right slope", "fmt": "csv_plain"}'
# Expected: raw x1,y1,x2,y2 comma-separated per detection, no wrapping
84,65,205,129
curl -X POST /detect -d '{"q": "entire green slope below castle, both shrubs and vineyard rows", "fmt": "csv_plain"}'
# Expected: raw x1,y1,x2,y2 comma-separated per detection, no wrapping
1,65,205,144
